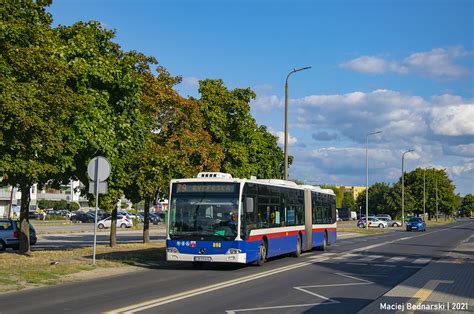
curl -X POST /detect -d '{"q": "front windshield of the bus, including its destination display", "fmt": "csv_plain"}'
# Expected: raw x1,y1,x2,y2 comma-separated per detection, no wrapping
169,183,238,241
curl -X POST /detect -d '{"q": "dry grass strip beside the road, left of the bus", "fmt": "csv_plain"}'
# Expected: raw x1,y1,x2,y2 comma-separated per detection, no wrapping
0,241,165,292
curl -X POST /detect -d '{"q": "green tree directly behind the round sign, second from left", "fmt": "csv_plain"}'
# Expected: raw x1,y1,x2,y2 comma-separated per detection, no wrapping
52,22,157,246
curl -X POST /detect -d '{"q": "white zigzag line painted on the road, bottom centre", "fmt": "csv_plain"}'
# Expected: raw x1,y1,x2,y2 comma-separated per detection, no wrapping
226,273,373,314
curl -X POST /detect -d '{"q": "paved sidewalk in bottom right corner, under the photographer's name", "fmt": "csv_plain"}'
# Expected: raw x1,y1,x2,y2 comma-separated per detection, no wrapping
358,234,474,314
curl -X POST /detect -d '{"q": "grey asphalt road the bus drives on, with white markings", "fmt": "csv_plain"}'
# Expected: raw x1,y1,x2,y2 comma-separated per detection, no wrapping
0,221,474,313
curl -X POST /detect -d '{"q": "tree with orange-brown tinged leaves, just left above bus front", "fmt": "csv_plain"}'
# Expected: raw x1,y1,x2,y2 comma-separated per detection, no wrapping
125,69,223,242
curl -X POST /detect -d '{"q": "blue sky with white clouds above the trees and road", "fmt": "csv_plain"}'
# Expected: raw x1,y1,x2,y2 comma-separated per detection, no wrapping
49,0,474,194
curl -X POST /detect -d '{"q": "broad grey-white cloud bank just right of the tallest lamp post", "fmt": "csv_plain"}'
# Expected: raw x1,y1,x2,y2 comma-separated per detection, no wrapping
292,89,429,142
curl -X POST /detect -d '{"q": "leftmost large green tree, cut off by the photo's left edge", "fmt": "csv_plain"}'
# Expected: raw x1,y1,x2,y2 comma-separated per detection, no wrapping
0,0,76,253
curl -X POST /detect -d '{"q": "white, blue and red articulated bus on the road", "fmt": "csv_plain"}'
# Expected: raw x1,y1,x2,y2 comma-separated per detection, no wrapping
166,172,336,265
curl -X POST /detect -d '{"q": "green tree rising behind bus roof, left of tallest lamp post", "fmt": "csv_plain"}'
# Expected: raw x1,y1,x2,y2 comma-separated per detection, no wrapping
198,80,284,178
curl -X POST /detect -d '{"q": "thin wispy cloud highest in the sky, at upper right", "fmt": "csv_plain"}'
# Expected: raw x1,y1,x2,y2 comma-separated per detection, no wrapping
339,47,472,79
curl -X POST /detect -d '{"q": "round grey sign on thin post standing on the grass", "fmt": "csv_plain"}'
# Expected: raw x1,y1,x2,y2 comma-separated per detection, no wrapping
87,156,110,265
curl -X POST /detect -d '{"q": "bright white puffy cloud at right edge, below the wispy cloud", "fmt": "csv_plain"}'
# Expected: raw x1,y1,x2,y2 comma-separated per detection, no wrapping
430,104,474,136
